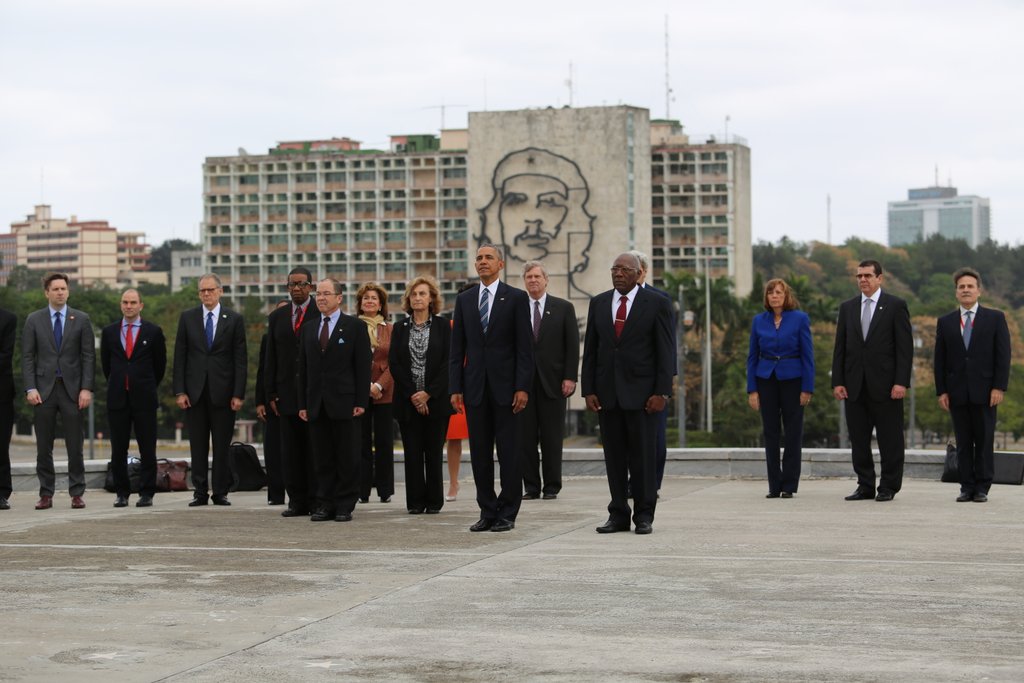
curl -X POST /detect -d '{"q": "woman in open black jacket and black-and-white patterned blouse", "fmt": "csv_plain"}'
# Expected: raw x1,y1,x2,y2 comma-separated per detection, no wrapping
388,276,452,515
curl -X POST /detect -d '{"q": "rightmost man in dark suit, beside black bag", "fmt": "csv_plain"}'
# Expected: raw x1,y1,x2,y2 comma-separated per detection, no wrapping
935,268,1010,503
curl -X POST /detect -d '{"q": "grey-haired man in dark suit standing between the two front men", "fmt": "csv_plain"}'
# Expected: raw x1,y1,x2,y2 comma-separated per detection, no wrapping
520,261,580,501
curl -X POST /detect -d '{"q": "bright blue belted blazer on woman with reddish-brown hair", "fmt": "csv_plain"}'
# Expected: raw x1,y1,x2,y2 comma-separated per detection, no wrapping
746,310,814,393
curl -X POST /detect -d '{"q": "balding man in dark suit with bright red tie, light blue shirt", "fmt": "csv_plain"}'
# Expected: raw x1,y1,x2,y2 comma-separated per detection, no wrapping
99,290,167,508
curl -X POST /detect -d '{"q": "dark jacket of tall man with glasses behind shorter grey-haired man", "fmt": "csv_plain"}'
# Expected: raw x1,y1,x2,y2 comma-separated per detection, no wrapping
256,298,321,415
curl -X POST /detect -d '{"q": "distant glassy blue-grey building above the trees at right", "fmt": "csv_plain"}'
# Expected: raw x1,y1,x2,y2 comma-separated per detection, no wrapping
889,186,991,248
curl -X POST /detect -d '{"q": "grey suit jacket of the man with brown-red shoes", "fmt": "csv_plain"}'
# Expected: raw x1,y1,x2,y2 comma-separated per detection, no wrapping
22,306,96,402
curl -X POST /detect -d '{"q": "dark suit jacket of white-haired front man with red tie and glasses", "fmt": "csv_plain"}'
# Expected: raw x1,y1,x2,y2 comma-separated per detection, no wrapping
581,288,674,411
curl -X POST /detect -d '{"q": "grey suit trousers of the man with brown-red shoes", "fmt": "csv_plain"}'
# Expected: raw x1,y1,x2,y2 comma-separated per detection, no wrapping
35,380,85,496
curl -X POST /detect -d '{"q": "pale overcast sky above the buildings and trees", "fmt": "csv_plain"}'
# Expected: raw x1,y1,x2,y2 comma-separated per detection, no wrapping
0,0,1024,246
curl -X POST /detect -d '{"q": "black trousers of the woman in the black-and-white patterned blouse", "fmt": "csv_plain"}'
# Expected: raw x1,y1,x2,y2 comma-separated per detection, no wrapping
399,413,447,510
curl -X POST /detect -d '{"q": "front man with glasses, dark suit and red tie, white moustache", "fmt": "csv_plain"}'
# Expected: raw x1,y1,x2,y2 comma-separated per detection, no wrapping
581,253,673,533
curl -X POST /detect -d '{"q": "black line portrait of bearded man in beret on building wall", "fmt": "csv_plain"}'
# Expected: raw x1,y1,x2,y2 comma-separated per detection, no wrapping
477,147,595,296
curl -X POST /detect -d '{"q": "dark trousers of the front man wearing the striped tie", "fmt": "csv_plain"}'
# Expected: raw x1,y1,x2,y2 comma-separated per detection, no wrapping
466,387,522,521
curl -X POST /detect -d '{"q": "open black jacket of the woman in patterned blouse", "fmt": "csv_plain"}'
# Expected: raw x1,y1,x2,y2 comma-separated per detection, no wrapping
388,315,452,420
